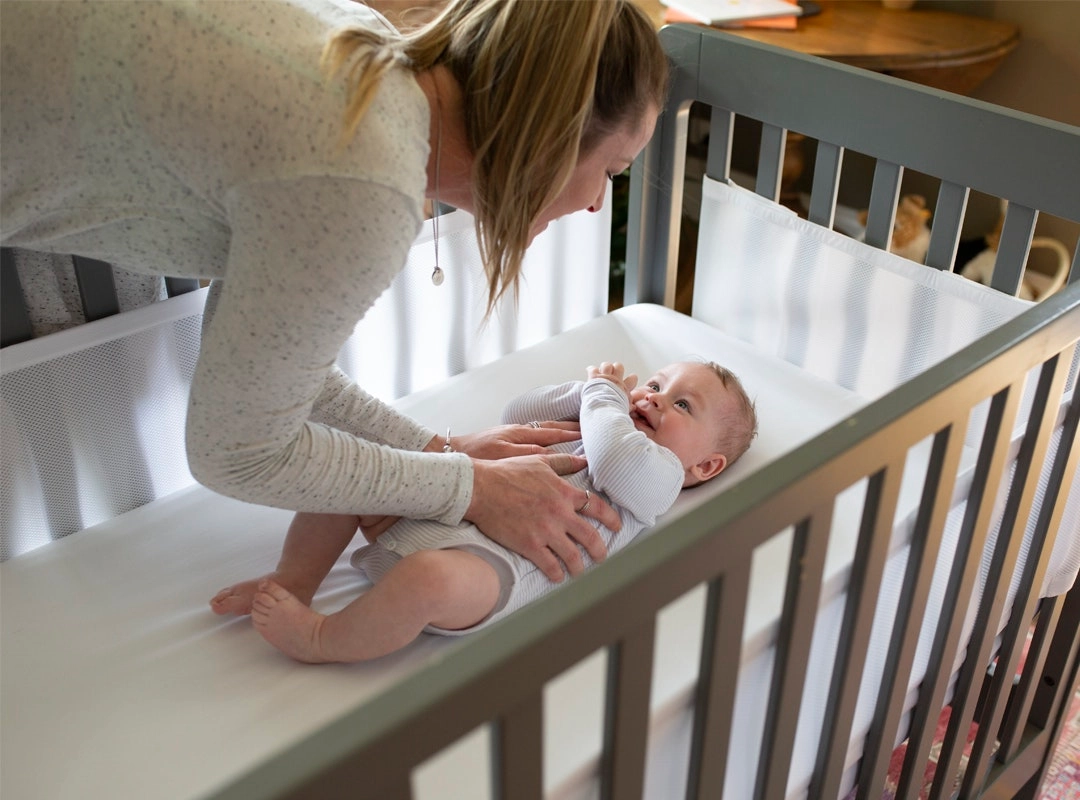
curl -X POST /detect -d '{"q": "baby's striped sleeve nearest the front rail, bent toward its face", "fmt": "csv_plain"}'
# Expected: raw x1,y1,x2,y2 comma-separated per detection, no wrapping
580,378,685,526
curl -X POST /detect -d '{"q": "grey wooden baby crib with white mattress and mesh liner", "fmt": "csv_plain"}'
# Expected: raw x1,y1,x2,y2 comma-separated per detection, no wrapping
0,25,1080,800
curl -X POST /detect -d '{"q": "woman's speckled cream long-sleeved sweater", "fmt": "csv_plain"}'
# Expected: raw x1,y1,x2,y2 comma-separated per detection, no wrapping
0,0,472,523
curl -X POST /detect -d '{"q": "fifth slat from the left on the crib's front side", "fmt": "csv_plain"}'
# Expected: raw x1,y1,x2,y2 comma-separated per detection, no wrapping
810,453,905,797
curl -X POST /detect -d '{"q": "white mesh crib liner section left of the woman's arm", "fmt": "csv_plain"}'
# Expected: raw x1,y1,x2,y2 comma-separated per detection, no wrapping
0,303,202,559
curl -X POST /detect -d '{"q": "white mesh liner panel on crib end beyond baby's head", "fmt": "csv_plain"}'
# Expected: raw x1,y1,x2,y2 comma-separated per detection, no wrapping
693,179,1030,398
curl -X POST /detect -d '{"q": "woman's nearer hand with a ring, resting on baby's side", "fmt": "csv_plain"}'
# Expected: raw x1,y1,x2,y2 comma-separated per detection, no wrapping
465,455,622,582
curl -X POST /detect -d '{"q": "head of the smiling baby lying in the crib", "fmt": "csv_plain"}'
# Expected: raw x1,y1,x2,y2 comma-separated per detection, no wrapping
630,362,757,487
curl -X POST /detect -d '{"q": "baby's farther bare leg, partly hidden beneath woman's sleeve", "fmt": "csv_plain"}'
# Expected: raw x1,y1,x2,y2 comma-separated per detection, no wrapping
210,514,360,615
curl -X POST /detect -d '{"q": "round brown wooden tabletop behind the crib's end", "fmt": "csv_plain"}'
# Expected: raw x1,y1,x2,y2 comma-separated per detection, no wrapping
635,0,1020,94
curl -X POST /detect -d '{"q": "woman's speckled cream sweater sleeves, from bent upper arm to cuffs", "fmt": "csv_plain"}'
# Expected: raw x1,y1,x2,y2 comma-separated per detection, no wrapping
187,177,472,524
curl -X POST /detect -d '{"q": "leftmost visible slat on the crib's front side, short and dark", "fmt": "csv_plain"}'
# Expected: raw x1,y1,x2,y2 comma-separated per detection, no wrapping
491,691,543,800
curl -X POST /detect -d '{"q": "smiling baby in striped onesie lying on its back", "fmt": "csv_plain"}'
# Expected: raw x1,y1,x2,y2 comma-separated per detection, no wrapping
211,362,757,663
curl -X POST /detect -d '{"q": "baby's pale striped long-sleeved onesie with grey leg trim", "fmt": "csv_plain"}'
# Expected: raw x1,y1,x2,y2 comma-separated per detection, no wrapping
351,378,686,636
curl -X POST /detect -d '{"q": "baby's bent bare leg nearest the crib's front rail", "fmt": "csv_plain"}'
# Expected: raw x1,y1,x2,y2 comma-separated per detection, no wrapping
252,550,499,663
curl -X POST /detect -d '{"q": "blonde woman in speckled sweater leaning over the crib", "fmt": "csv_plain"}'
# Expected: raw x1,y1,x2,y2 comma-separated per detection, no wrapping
0,0,666,580
